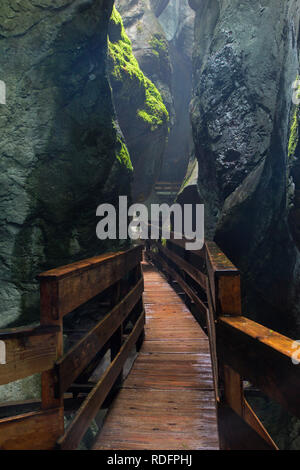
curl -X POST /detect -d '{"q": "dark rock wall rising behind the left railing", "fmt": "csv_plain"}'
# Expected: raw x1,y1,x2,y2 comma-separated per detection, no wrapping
0,0,131,327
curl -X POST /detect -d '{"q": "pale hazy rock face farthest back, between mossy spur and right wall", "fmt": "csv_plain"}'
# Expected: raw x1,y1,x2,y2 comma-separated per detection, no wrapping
116,0,194,185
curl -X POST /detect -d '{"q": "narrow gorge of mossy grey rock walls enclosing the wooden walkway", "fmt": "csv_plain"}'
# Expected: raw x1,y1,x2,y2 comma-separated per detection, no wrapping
0,0,300,449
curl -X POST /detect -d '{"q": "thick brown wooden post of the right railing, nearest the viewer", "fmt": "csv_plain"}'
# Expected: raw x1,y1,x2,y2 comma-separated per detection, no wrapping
206,242,277,450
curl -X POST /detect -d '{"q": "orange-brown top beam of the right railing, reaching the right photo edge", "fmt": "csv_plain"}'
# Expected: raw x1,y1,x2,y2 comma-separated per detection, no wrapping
216,316,300,418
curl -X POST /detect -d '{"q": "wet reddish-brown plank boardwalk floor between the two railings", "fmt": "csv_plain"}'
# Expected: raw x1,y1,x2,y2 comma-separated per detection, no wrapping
94,263,219,450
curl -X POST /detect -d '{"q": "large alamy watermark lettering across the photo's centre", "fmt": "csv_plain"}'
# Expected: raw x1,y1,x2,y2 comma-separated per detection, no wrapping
96,196,204,250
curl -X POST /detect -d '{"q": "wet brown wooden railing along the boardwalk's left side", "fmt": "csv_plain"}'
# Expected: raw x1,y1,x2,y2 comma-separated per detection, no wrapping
0,247,145,449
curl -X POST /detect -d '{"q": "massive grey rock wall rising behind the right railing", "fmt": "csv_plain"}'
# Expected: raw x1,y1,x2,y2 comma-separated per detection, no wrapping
190,0,300,334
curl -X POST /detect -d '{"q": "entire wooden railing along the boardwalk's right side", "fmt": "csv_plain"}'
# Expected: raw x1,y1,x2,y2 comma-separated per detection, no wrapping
147,233,300,450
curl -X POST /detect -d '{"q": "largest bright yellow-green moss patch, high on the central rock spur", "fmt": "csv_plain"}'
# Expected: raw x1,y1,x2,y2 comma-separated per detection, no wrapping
108,7,169,130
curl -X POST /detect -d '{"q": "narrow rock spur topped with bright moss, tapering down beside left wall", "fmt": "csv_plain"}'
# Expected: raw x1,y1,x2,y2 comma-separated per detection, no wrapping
108,8,169,201
